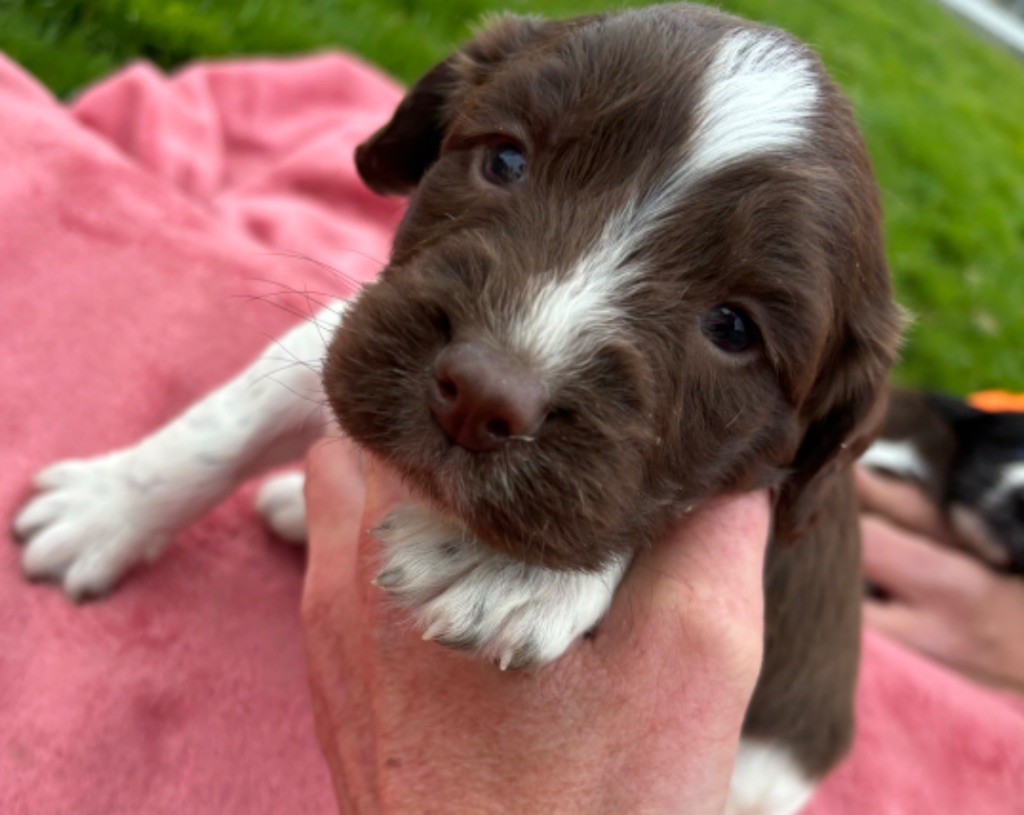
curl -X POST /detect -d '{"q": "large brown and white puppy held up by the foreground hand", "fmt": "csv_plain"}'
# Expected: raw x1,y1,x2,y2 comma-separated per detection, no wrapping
17,4,899,814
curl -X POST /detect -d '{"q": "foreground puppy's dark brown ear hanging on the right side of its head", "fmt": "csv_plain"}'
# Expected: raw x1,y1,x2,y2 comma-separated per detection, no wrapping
774,302,904,546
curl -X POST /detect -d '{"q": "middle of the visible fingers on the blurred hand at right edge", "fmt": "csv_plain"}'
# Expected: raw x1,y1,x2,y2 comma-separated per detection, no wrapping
860,515,991,611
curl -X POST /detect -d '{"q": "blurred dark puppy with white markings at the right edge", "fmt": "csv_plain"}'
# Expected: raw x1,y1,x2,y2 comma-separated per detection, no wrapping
861,389,1024,574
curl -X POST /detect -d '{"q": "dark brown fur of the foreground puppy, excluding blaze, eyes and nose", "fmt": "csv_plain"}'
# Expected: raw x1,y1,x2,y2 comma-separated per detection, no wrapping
325,4,898,773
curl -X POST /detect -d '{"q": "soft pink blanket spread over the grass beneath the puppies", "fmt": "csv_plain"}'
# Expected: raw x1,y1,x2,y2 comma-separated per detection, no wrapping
0,56,1024,815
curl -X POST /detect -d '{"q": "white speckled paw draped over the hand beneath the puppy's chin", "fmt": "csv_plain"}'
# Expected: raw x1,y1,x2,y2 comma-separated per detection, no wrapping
374,505,627,670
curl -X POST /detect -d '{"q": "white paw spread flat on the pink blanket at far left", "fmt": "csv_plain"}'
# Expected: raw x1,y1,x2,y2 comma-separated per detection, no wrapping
13,449,173,600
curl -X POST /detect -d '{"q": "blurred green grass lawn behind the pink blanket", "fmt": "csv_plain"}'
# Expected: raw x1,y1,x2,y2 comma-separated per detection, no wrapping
0,0,1024,392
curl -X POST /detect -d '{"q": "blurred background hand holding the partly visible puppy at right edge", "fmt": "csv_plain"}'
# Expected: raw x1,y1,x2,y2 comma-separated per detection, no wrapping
856,468,1024,693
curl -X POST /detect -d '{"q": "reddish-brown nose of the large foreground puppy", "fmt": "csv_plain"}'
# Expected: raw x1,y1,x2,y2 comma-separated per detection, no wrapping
430,342,547,452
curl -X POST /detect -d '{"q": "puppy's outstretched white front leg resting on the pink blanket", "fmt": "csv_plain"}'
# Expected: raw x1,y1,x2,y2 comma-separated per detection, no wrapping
14,302,345,600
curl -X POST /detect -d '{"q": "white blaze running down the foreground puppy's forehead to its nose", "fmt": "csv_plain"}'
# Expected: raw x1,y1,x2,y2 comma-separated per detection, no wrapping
507,30,820,372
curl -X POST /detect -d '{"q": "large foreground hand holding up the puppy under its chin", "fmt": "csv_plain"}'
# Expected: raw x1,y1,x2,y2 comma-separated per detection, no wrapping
303,442,769,815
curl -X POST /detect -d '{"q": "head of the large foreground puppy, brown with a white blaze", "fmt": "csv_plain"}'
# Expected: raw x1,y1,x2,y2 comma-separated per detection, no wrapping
325,4,897,567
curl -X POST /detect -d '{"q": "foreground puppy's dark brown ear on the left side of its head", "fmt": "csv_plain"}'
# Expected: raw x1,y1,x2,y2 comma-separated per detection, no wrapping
355,14,554,196
